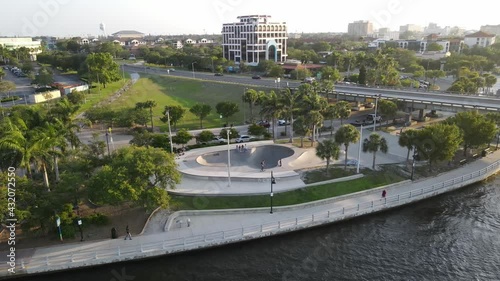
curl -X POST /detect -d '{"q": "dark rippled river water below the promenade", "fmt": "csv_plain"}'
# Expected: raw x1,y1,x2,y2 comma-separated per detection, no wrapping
15,177,500,281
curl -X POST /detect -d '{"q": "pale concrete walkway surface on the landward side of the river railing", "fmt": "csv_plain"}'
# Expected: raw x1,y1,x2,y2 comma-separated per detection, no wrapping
0,149,500,272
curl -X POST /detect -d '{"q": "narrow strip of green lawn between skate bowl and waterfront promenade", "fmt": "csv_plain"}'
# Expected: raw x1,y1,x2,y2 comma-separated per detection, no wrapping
171,168,405,210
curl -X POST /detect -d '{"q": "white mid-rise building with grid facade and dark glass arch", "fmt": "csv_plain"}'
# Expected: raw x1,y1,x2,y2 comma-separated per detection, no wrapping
222,15,288,65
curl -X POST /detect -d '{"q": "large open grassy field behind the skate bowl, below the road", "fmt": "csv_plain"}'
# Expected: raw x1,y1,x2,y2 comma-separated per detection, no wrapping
112,74,270,131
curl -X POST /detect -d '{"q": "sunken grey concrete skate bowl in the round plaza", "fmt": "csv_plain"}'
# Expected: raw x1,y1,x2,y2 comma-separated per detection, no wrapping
196,145,295,169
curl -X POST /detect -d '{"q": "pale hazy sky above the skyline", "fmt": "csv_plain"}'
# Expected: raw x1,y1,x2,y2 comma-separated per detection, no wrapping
0,0,500,37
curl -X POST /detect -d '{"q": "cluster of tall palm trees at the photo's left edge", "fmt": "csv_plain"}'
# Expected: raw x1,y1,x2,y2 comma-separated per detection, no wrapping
0,98,80,189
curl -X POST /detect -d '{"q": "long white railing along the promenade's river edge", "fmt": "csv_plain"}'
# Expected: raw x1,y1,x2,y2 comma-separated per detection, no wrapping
10,161,500,271
